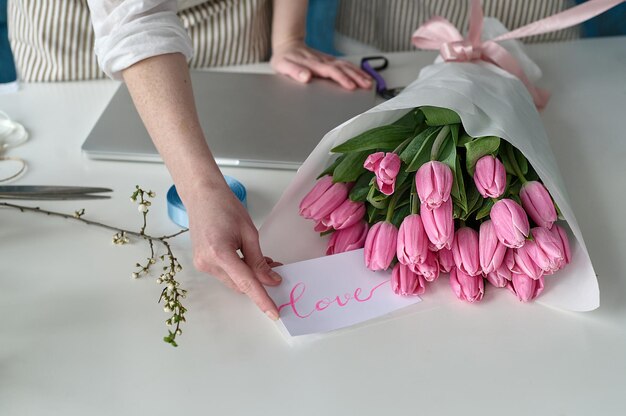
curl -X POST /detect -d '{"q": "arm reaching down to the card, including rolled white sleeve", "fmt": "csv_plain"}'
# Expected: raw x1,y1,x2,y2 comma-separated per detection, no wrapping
88,0,280,319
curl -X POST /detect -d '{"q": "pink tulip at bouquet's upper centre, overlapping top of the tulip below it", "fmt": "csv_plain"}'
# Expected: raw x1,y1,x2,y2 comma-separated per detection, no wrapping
415,161,453,209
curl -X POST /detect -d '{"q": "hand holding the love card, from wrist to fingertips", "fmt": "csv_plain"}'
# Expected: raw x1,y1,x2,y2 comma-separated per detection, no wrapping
187,184,281,320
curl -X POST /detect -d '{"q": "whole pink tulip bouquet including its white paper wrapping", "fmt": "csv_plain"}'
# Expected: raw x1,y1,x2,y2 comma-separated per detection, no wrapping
260,17,599,311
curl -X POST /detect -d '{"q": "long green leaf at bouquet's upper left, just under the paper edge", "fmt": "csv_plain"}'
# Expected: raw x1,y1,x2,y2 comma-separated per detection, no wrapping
331,124,415,153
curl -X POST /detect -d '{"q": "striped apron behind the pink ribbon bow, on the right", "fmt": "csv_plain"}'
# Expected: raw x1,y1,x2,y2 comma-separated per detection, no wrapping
337,0,580,52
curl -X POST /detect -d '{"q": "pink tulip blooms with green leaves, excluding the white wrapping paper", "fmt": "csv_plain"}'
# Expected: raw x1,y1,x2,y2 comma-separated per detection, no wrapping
299,106,571,302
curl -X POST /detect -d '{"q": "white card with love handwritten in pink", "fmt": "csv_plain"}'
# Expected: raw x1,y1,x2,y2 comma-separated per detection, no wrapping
266,250,421,336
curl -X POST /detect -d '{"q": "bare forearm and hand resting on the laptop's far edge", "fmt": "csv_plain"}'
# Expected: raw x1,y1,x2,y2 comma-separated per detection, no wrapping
270,0,372,90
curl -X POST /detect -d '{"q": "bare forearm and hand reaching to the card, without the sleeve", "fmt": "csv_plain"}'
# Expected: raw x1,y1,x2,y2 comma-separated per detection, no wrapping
122,53,280,319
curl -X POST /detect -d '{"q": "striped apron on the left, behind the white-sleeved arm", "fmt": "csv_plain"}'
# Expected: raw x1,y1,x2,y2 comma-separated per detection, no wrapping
8,0,271,82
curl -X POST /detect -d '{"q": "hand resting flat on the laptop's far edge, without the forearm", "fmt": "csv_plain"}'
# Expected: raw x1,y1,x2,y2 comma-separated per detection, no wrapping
270,40,372,90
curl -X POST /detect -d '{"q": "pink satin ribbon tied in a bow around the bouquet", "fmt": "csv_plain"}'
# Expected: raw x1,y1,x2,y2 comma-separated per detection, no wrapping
412,0,626,109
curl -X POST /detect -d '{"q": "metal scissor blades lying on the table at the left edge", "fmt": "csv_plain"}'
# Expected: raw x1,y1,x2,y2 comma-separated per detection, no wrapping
0,185,113,201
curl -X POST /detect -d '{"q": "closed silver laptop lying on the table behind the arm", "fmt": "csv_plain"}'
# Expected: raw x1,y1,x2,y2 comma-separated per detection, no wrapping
82,71,374,169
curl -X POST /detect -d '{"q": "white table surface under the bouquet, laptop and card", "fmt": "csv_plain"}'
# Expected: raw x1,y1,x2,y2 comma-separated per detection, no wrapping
0,37,626,416
